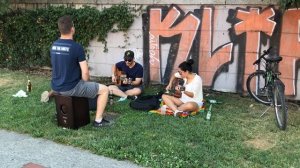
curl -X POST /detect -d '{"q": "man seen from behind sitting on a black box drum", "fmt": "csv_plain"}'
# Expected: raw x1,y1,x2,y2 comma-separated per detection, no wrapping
50,16,110,127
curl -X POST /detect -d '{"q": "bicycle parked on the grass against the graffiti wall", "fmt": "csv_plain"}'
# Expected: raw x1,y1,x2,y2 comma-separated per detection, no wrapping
246,47,288,130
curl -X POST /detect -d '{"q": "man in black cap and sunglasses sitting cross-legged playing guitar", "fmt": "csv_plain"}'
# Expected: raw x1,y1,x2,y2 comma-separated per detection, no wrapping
108,50,143,101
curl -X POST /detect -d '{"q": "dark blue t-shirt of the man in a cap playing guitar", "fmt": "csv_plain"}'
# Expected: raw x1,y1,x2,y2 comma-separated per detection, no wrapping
116,61,143,81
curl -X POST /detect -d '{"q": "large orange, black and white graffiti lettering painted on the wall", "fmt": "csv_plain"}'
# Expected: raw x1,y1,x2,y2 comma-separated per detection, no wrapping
143,5,300,96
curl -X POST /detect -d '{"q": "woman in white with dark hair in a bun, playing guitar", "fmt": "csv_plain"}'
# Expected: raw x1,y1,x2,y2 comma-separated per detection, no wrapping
162,59,203,116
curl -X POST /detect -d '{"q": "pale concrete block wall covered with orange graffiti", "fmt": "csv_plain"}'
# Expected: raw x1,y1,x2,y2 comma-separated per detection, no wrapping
13,0,300,99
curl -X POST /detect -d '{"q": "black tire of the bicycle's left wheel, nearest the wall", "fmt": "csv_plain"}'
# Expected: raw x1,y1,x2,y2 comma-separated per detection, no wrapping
246,70,272,105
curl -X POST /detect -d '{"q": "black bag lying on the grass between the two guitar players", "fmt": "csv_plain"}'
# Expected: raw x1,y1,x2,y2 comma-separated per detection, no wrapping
129,95,161,111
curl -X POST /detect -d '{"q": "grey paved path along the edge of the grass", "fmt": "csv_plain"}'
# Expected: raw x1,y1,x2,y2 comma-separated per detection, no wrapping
0,130,139,168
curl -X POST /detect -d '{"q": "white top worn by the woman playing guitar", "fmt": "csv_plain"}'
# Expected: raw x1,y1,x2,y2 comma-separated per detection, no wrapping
174,72,203,105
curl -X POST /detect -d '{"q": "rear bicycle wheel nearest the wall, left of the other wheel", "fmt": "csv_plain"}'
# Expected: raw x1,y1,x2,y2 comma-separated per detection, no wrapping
246,70,272,105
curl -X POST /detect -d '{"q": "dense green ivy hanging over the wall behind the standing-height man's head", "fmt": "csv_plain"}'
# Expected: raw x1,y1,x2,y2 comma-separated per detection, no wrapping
0,4,135,69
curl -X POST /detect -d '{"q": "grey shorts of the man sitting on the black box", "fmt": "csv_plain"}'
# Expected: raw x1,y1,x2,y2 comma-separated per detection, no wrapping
59,80,100,98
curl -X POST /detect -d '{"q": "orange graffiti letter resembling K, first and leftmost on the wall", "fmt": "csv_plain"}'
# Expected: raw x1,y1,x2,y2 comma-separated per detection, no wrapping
149,6,200,81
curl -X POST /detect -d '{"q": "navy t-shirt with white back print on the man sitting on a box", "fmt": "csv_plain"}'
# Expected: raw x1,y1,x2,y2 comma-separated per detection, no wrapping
50,39,85,92
